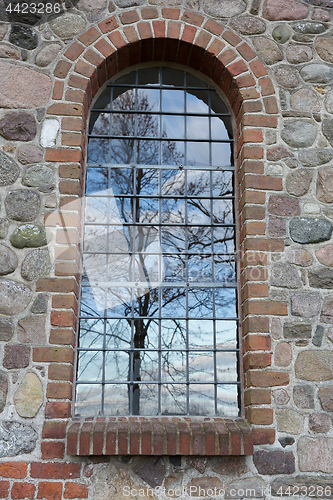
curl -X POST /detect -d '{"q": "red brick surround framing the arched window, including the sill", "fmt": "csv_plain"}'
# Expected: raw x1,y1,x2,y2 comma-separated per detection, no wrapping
40,8,289,455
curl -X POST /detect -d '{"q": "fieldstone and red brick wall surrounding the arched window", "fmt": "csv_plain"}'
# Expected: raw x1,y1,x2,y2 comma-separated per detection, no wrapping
0,0,333,500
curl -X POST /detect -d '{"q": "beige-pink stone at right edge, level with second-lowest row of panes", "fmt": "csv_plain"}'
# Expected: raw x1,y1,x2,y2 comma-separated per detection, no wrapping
295,350,333,382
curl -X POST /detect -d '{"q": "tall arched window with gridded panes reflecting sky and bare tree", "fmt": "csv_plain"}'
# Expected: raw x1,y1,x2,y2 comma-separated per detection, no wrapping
76,67,240,416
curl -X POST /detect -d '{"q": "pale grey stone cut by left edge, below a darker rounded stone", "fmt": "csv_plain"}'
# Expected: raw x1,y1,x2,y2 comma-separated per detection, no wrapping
0,278,32,316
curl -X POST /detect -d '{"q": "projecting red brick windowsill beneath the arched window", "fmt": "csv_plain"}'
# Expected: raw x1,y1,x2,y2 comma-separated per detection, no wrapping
67,417,253,456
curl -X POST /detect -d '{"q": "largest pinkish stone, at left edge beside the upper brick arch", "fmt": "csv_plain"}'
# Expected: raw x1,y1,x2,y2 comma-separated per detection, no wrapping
0,61,52,109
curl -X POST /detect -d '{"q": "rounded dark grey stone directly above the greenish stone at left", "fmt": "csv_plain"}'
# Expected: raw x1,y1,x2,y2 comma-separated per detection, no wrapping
5,189,40,222
